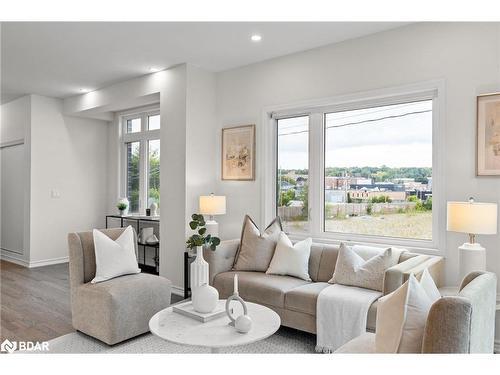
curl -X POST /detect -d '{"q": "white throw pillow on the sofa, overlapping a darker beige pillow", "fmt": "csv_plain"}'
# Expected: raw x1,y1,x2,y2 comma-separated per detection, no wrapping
266,232,312,281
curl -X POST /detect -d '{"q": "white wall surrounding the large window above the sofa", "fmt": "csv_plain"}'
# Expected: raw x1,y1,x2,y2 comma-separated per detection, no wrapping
216,23,500,283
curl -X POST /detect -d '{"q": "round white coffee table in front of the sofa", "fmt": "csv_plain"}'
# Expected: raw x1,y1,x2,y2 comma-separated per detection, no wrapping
149,300,281,353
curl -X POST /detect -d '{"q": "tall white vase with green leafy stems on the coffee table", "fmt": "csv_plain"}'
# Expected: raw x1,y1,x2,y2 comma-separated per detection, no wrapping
186,214,220,312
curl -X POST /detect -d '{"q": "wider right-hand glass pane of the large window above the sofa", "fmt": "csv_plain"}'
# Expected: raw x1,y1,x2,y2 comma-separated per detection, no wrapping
324,100,432,240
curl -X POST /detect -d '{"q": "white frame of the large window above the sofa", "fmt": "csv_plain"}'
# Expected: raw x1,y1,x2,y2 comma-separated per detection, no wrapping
260,80,446,254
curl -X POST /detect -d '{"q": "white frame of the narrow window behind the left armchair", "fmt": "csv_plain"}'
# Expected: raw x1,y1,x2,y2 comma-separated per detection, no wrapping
119,106,161,215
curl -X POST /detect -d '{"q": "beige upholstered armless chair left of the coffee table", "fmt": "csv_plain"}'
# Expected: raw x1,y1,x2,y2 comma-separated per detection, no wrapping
68,228,171,345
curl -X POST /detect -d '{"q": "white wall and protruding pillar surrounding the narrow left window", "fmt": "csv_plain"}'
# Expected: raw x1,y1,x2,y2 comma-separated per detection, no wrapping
64,64,216,292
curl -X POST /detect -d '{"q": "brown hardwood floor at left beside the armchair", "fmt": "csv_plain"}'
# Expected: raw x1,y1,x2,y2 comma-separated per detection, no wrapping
0,260,182,342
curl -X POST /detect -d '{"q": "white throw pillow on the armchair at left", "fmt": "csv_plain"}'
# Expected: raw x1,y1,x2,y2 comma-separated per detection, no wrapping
91,226,141,283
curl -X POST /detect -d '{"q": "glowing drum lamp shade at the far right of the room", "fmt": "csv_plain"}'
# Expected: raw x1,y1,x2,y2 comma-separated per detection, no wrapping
446,202,497,234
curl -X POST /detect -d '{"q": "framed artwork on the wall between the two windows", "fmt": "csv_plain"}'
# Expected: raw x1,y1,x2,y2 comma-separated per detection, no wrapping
221,125,255,181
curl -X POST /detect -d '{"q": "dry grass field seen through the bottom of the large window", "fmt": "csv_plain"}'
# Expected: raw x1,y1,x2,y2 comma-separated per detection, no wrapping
284,211,432,240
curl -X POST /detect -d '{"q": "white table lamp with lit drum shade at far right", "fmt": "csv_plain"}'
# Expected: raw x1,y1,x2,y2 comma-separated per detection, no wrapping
446,198,497,280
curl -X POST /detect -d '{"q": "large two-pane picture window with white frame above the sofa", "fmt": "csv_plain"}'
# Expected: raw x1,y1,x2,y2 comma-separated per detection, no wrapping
270,89,441,248
